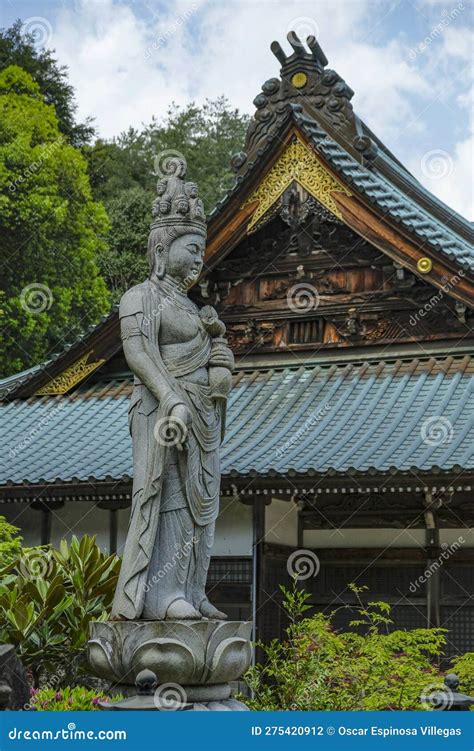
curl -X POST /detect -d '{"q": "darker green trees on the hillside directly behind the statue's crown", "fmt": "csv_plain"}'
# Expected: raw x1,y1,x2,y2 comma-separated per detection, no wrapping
83,97,248,300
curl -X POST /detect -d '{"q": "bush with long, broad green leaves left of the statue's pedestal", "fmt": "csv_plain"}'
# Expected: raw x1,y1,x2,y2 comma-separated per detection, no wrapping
0,535,120,687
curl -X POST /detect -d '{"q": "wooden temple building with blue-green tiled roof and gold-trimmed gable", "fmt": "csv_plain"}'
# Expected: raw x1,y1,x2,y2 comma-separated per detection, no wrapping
0,34,474,656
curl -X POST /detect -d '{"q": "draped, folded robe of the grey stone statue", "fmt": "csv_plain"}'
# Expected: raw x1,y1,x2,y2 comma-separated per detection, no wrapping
112,281,221,619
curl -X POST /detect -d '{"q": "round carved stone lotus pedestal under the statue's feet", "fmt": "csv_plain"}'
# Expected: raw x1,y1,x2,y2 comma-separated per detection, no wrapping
87,620,252,710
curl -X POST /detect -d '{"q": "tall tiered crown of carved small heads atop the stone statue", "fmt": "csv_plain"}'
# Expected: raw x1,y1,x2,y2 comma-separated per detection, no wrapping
151,156,206,233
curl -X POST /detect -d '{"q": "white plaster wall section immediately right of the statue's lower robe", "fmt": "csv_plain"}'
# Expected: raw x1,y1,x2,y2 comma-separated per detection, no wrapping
212,497,253,555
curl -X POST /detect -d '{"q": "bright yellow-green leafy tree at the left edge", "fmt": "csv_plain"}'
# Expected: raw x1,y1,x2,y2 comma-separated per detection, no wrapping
0,66,109,375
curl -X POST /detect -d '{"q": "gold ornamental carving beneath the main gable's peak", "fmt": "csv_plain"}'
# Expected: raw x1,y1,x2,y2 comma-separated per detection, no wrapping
242,138,351,230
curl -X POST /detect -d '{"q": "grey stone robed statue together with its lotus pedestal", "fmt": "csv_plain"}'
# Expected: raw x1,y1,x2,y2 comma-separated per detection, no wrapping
87,154,252,711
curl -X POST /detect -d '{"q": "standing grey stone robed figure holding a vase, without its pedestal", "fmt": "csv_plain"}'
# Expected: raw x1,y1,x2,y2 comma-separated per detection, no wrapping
112,159,234,620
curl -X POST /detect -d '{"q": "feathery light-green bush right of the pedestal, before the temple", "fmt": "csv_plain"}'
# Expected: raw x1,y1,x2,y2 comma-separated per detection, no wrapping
245,583,445,710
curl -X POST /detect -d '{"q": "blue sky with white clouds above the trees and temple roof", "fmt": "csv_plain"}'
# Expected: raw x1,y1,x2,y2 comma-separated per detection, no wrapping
0,0,474,219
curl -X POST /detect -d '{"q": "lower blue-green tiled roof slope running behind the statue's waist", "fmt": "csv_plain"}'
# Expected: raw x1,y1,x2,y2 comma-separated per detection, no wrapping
0,356,474,485
